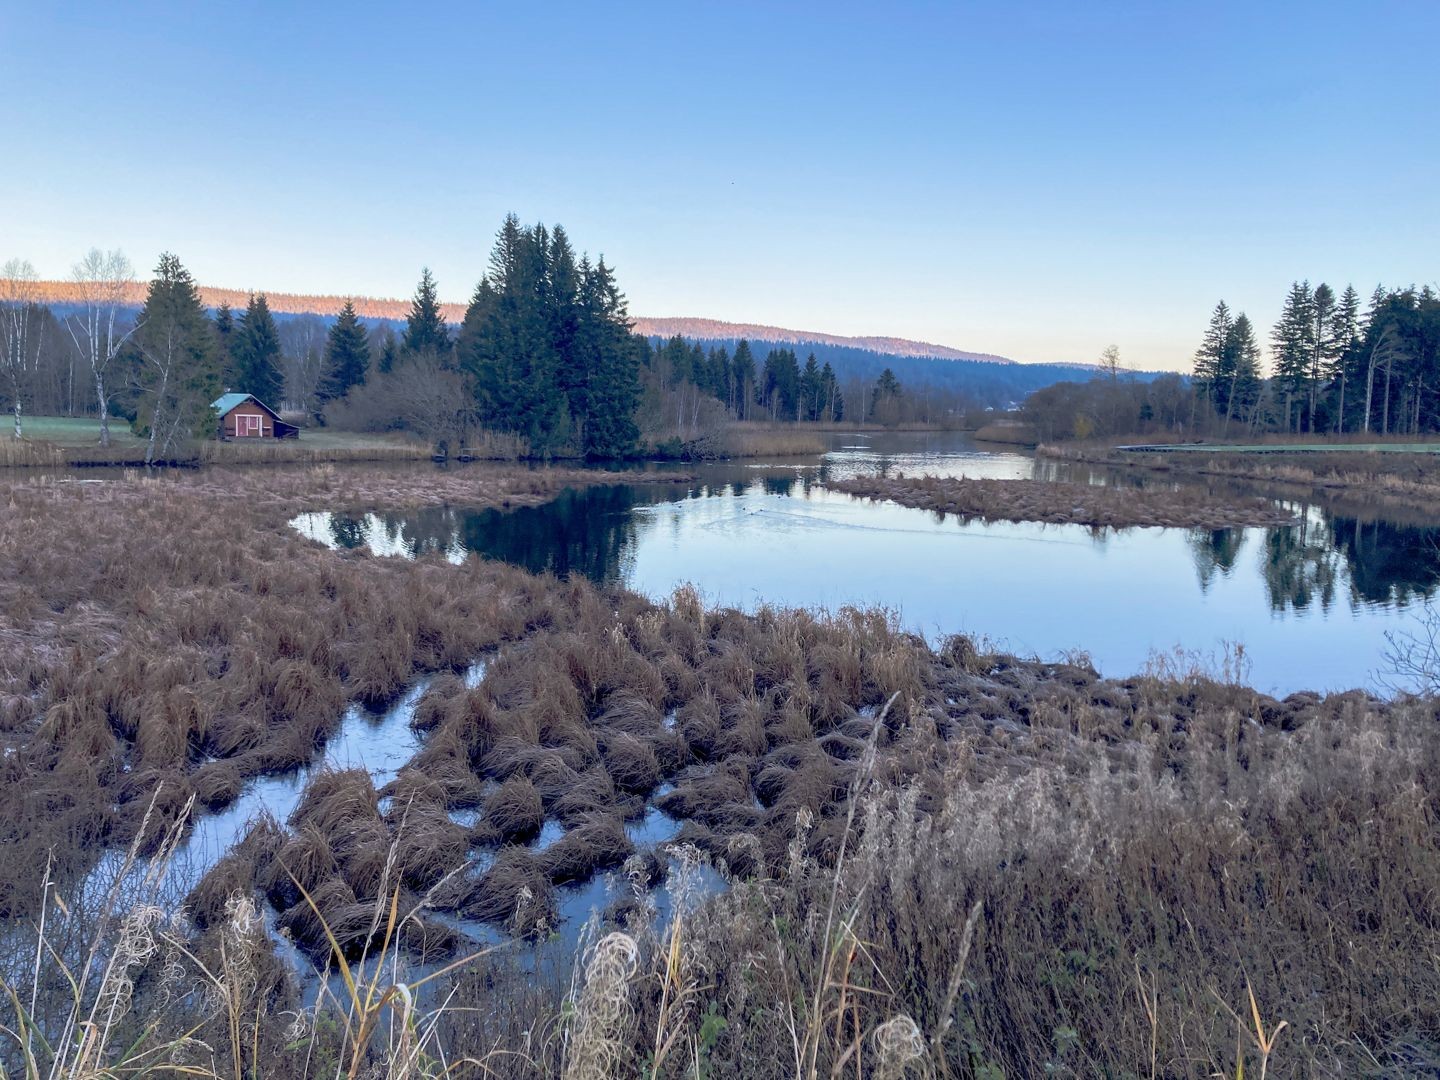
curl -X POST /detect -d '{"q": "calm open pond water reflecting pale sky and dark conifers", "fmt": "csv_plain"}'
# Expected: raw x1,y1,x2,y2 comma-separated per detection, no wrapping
295,435,1440,693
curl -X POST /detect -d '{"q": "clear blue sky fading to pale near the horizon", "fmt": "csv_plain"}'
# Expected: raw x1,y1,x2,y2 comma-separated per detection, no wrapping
0,0,1440,370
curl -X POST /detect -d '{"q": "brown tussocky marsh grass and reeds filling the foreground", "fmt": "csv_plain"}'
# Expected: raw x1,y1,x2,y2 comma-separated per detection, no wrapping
0,468,1440,1080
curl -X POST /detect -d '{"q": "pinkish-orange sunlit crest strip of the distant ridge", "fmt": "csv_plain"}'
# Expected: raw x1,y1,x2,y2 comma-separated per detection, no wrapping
25,281,1015,364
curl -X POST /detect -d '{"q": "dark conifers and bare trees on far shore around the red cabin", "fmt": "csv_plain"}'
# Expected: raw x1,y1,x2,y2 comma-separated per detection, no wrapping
0,215,933,461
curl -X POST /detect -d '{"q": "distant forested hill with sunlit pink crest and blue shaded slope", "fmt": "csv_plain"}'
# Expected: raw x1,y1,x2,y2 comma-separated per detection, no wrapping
22,281,1148,408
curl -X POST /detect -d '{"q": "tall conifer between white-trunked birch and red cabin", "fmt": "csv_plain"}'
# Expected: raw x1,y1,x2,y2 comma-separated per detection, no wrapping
131,252,220,465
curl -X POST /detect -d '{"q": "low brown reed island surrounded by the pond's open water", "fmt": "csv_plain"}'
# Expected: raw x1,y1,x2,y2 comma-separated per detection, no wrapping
827,475,1295,528
